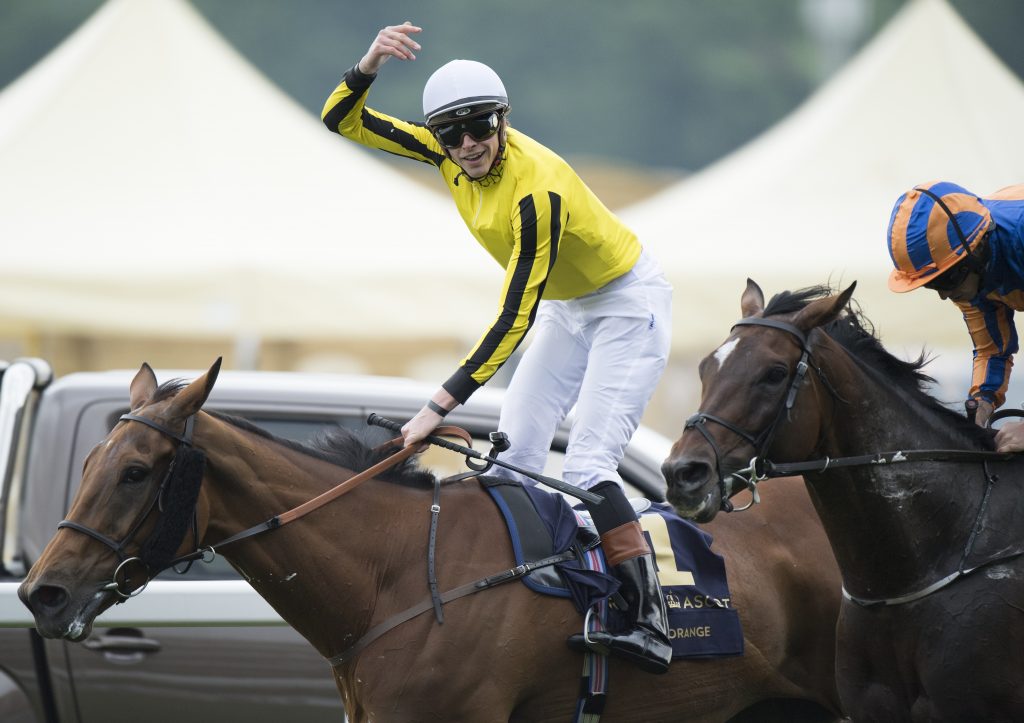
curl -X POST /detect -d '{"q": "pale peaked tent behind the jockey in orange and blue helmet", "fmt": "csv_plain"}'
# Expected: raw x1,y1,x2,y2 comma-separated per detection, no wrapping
620,0,1024,354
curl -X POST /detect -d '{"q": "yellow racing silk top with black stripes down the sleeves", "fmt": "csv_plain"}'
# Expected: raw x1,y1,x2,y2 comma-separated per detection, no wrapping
322,68,640,402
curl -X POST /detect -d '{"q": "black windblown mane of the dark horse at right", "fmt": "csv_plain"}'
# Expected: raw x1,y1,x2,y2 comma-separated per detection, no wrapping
764,285,994,449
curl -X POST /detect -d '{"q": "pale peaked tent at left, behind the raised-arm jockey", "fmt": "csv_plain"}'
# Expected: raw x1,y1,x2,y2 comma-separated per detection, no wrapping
0,0,501,339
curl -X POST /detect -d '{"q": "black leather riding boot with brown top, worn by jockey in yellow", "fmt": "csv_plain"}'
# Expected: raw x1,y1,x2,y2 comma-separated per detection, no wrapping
569,522,672,674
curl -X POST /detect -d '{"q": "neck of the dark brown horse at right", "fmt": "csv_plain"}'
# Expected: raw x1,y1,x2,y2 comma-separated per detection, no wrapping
807,344,981,597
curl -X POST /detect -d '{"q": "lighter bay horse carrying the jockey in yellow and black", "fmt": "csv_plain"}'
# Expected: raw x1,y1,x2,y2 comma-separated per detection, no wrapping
19,360,839,723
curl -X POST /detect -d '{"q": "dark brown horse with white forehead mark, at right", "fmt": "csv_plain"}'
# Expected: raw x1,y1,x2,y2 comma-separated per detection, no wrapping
662,280,1024,721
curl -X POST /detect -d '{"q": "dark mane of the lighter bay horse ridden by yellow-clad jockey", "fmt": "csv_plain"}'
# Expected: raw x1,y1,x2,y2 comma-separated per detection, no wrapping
150,379,434,486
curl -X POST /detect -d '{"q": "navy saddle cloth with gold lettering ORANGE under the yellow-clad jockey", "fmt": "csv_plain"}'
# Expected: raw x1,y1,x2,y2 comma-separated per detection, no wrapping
479,477,743,657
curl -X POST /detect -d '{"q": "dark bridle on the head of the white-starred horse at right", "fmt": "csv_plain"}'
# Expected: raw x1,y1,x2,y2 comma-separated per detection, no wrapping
683,316,811,512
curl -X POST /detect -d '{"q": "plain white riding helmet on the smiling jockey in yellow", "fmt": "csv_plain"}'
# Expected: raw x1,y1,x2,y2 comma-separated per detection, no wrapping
423,60,509,126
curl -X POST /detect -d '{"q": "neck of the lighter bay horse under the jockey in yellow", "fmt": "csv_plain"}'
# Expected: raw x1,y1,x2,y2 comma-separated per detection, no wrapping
193,424,423,655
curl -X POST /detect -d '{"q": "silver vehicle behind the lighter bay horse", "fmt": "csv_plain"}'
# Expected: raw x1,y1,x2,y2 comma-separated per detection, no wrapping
0,359,670,723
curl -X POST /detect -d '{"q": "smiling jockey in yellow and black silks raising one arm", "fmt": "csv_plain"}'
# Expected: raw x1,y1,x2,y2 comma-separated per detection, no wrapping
323,23,672,673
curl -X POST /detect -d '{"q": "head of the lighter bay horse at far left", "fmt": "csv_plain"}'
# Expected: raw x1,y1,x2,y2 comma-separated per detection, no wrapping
18,359,220,640
